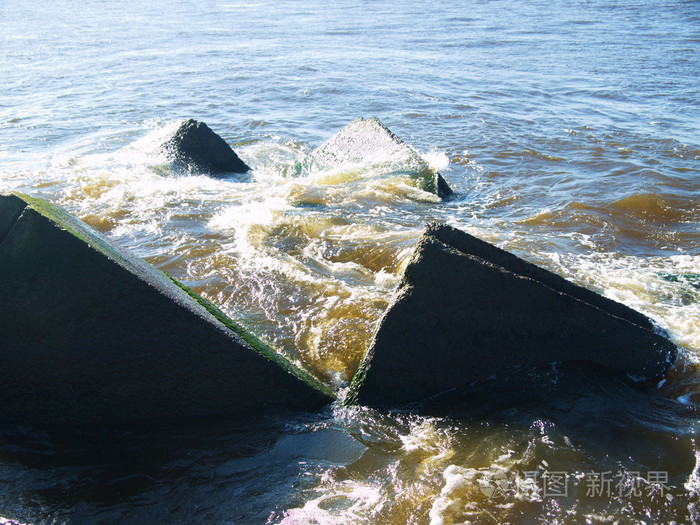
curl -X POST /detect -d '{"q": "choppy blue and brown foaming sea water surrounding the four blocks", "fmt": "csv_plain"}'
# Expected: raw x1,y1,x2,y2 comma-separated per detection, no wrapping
0,0,700,525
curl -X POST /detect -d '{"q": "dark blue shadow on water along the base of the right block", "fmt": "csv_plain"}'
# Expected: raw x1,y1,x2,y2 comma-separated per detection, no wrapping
422,362,700,430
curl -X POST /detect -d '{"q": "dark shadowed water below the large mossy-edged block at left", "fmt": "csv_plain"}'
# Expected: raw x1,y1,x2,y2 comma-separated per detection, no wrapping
0,406,340,523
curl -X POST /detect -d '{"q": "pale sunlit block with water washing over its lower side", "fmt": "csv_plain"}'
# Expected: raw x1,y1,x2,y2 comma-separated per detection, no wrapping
311,118,453,199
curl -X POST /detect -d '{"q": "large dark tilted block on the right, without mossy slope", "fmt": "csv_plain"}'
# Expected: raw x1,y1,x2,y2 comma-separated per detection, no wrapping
351,224,677,406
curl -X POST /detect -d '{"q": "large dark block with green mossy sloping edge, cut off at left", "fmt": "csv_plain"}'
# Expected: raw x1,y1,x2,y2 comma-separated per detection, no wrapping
0,194,332,424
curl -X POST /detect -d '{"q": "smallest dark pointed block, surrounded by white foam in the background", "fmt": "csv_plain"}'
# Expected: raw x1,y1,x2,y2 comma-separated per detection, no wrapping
160,119,250,175
